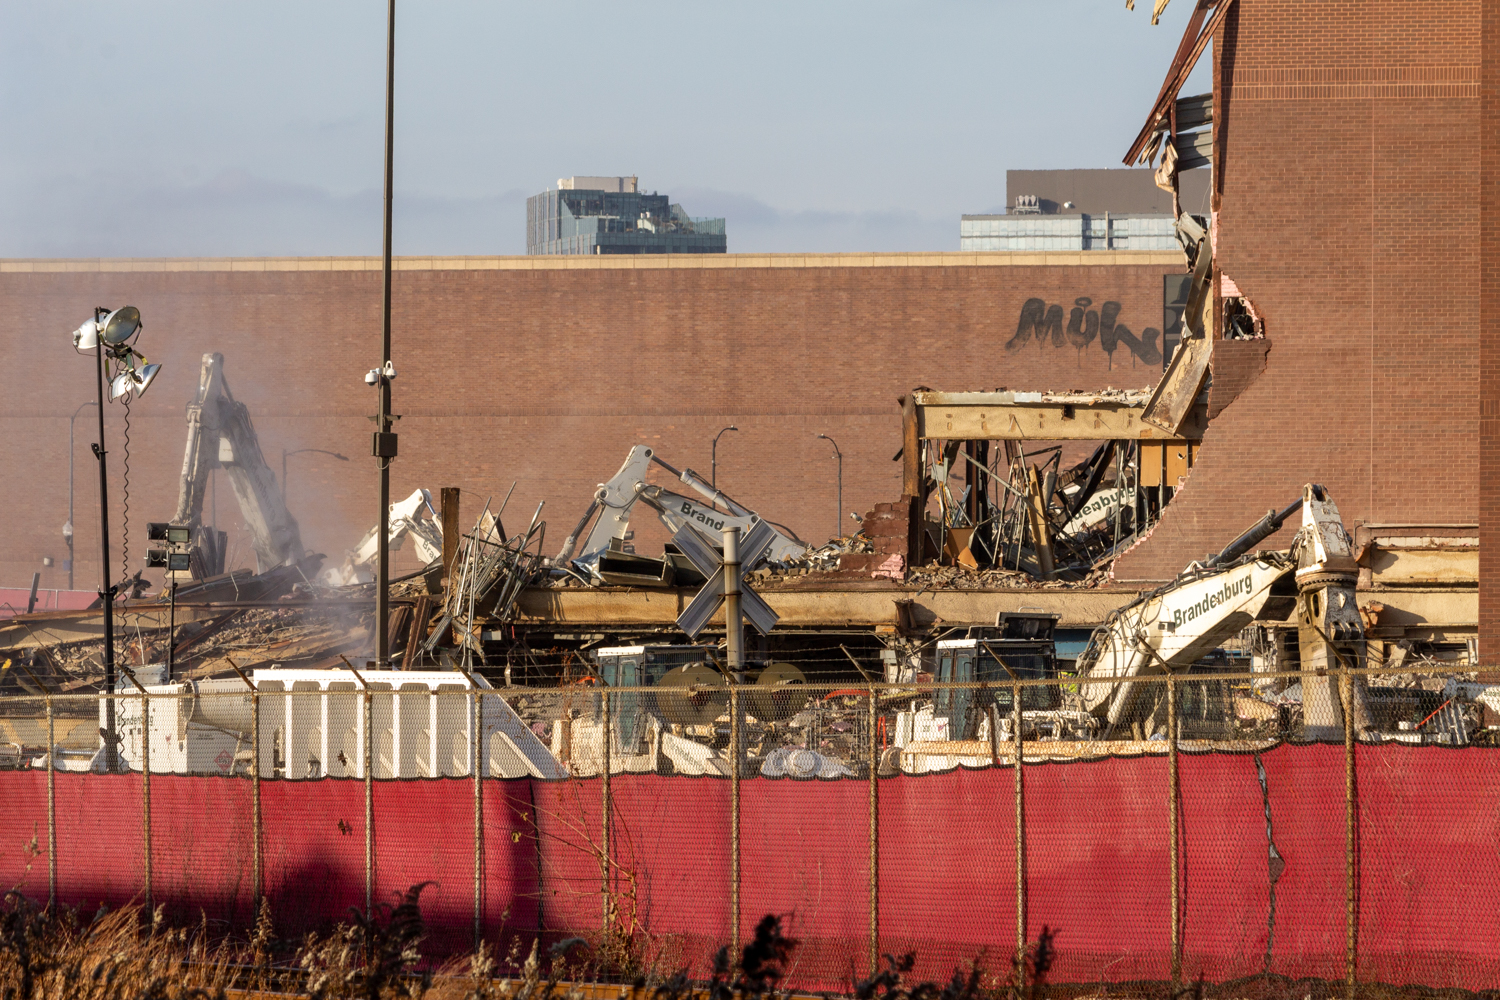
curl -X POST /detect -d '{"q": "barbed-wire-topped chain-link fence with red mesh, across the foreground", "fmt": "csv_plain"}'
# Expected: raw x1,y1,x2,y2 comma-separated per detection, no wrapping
0,663,1500,997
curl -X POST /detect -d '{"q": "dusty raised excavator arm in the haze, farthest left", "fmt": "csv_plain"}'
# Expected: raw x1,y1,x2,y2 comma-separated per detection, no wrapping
171,354,305,577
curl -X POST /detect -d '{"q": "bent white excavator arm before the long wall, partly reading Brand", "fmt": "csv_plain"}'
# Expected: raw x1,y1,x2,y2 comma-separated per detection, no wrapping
554,444,807,583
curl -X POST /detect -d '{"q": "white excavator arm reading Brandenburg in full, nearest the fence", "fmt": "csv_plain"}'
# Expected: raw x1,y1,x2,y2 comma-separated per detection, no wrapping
1077,483,1373,739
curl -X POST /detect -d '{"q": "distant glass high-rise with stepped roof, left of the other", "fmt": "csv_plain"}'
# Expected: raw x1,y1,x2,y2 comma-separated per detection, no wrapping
527,177,729,253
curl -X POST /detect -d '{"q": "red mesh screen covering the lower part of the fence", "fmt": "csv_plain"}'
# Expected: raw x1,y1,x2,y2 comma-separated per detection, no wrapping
0,680,1500,996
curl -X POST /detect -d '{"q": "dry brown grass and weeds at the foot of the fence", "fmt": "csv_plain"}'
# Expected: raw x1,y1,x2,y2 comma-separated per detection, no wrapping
0,885,1052,1000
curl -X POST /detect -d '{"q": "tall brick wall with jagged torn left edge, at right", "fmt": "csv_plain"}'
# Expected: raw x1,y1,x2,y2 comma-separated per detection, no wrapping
1116,0,1482,579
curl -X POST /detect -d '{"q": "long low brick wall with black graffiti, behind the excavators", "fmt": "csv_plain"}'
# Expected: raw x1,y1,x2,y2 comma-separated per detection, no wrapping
0,253,1181,589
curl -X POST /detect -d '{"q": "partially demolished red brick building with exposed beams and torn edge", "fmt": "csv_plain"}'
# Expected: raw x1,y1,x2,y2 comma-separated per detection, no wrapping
0,3,1485,671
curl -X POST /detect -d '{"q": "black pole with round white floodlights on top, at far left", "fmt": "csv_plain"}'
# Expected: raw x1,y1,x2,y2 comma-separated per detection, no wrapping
69,306,162,771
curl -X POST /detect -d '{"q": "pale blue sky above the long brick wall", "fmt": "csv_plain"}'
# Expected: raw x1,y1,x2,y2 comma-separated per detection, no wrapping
0,0,1209,256
